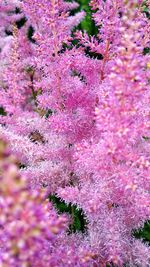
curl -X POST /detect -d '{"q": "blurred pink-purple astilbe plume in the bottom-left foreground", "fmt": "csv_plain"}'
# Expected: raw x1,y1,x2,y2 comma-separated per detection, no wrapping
0,139,94,267
